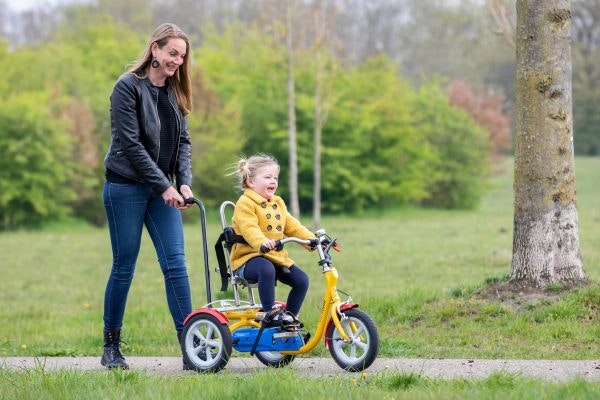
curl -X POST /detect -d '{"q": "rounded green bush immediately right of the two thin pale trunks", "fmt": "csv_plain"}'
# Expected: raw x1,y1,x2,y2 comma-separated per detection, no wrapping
314,56,432,212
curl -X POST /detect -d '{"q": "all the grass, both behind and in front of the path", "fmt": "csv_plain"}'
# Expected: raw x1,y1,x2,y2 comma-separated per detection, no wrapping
0,158,600,399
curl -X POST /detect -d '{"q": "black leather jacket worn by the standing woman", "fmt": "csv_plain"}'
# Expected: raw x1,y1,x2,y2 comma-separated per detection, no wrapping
104,73,192,197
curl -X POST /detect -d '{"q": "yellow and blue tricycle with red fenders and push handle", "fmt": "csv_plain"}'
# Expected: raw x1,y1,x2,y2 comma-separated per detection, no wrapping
181,198,379,372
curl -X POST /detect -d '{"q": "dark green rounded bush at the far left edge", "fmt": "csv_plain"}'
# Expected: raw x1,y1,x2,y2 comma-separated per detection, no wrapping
0,92,75,229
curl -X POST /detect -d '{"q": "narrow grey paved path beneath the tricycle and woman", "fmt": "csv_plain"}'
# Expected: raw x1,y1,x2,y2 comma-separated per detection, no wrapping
0,357,600,382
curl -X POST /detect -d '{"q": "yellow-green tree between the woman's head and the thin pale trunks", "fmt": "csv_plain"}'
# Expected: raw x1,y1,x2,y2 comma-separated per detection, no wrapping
194,26,287,193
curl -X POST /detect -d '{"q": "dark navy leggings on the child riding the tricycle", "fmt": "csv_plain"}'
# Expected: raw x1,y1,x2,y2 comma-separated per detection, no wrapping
244,257,308,315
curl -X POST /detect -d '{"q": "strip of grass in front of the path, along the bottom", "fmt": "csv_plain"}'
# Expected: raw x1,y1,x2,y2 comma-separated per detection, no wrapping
0,369,600,400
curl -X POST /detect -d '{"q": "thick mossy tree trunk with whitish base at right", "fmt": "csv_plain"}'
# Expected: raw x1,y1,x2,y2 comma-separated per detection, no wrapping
510,0,586,288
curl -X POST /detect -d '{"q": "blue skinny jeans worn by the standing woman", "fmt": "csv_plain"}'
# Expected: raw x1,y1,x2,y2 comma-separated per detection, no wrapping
103,181,192,331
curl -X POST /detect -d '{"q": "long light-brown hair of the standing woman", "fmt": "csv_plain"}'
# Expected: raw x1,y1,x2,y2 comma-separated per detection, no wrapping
129,22,192,115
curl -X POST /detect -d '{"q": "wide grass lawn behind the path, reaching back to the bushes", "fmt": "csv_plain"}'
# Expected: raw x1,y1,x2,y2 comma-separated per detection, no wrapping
0,158,600,359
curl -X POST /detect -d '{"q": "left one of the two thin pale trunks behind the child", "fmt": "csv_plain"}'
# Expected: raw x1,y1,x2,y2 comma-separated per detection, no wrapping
286,0,300,218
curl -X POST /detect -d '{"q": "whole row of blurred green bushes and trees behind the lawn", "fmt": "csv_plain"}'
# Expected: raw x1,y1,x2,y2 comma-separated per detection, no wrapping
0,13,489,230
